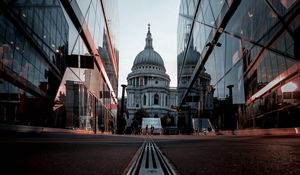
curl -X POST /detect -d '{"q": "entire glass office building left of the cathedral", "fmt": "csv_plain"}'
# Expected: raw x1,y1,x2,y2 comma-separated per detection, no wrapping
0,0,119,131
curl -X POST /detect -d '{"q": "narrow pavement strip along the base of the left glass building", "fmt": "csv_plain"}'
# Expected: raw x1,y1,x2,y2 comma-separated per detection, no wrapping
0,124,111,135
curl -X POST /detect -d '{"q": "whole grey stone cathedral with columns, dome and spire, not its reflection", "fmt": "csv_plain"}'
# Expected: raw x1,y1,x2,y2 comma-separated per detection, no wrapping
127,25,177,126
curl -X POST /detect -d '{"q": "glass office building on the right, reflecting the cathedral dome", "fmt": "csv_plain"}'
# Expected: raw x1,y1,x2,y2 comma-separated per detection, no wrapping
177,0,300,129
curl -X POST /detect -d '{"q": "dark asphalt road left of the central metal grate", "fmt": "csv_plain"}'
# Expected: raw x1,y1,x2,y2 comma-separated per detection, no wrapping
0,133,144,175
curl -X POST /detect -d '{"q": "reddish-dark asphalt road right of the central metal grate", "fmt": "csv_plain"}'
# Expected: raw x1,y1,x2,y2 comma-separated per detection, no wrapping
154,136,300,175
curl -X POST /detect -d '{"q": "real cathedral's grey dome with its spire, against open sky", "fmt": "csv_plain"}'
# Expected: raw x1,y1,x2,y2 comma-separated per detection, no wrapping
133,25,165,69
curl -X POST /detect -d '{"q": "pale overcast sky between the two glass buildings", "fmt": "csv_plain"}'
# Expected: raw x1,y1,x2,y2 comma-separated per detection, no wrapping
118,0,180,97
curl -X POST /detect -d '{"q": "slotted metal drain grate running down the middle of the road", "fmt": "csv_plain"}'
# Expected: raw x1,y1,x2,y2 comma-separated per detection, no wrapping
126,141,176,175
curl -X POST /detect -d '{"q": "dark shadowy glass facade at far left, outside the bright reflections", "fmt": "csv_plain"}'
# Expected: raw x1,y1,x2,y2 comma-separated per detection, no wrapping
0,1,69,126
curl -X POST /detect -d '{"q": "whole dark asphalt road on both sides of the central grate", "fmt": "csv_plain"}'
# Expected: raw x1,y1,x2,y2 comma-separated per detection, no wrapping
0,133,300,175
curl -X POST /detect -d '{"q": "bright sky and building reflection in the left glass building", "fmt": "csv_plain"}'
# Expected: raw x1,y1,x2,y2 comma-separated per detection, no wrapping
56,0,118,132
